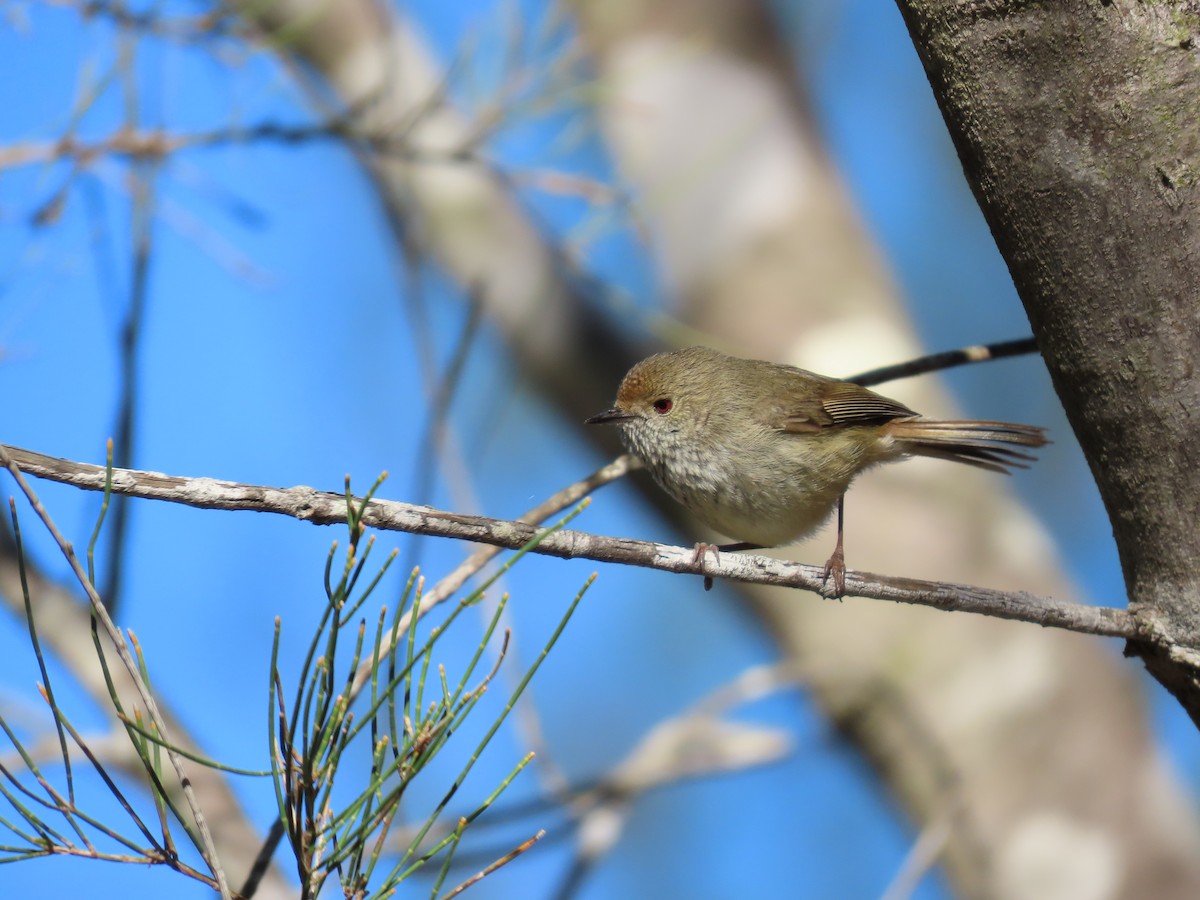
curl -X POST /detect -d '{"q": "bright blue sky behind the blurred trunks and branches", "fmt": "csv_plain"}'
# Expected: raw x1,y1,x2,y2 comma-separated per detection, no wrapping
0,0,1200,898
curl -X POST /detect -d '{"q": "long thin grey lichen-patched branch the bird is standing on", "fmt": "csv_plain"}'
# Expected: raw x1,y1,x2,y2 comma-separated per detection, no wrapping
0,444,1137,641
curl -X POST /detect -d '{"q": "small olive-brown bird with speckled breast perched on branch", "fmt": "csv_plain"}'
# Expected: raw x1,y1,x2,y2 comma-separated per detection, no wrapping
587,347,1046,596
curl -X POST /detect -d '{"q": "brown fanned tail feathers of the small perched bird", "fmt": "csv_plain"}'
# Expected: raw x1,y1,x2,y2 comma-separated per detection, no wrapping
888,418,1050,475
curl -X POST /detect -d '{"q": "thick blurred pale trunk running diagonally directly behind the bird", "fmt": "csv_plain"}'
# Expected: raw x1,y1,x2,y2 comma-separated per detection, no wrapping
576,0,1200,899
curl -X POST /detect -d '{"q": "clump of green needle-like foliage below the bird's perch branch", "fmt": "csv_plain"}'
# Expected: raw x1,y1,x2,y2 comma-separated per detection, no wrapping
269,482,590,898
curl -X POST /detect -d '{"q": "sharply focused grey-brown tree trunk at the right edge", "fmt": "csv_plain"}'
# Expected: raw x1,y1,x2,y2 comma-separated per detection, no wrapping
900,0,1200,722
